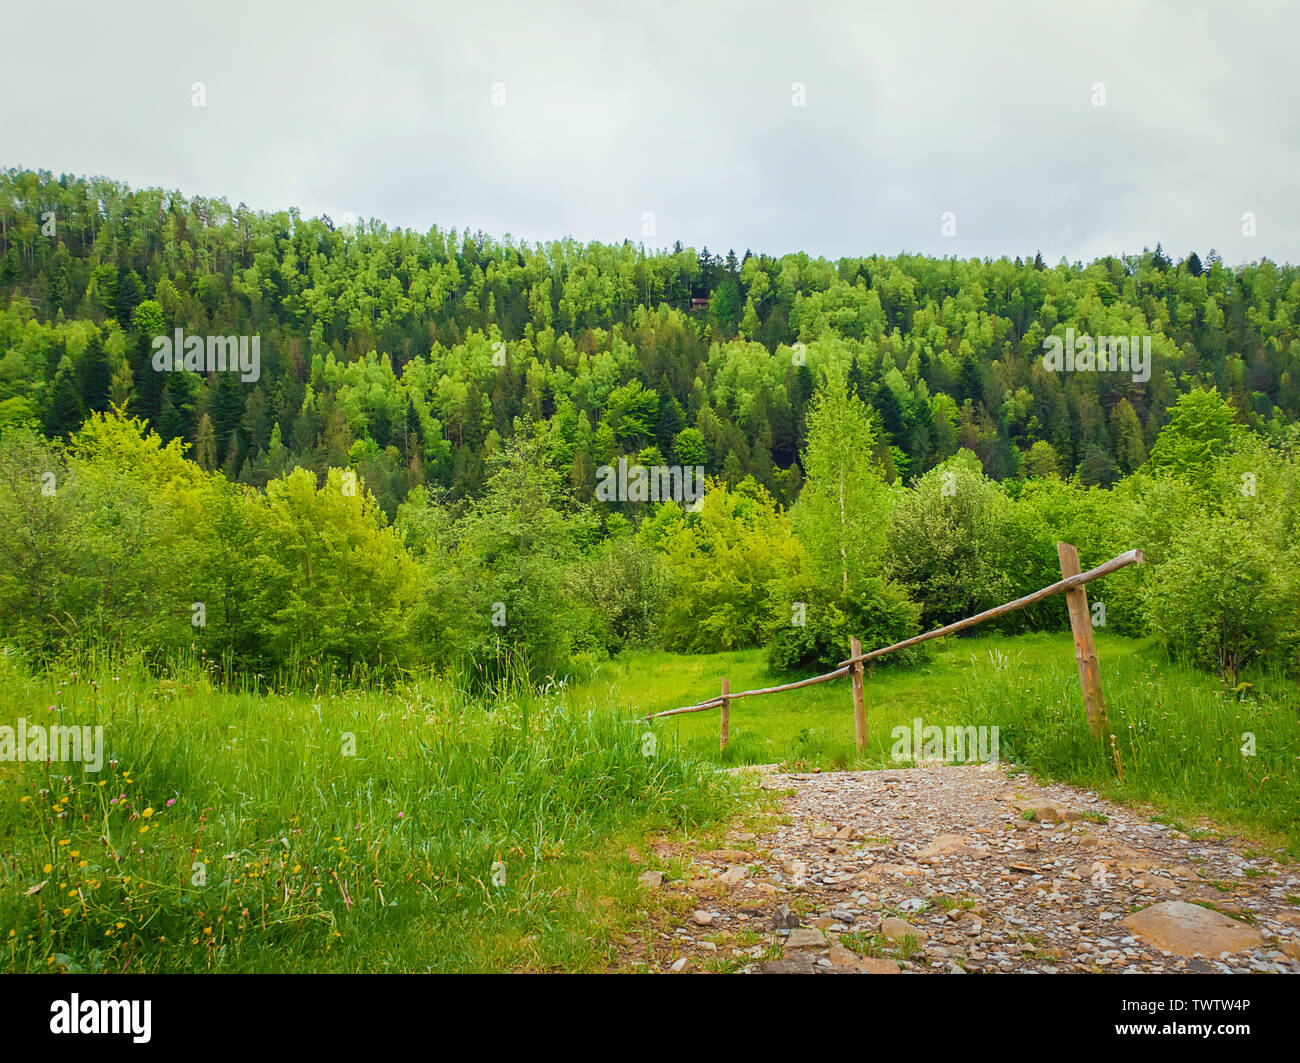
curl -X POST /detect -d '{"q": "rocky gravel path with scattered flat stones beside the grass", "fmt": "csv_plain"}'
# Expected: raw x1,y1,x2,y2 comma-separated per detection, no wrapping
625,765,1300,973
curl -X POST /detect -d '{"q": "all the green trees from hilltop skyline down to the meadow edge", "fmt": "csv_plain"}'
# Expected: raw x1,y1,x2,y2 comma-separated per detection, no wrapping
0,170,1300,676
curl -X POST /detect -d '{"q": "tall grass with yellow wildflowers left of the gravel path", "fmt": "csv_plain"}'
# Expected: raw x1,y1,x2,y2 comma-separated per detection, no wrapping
0,655,744,972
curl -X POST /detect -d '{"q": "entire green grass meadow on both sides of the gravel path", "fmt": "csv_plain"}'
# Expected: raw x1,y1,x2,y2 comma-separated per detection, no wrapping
0,634,1300,971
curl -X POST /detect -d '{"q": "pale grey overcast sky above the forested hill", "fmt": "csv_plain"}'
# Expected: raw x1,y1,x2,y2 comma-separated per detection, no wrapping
0,0,1300,263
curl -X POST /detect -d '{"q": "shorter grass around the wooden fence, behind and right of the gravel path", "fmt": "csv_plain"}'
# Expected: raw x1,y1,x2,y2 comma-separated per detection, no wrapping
588,633,1300,855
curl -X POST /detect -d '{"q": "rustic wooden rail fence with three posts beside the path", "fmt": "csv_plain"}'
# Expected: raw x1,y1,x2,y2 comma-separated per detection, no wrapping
646,543,1143,752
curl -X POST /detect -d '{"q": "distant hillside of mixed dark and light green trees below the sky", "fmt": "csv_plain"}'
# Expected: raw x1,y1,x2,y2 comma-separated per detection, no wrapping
0,170,1300,515
